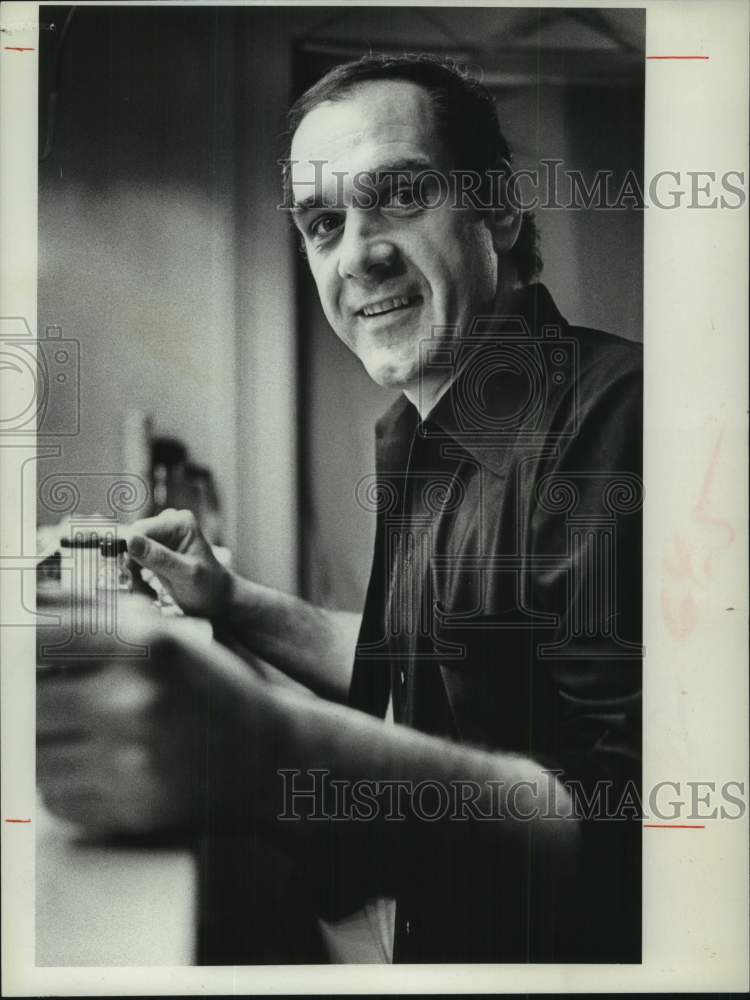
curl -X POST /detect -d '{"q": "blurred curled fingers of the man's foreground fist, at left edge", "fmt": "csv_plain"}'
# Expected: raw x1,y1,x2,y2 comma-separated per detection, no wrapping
37,661,194,834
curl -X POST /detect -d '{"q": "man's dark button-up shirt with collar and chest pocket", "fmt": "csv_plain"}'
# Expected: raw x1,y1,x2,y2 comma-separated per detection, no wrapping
350,284,642,962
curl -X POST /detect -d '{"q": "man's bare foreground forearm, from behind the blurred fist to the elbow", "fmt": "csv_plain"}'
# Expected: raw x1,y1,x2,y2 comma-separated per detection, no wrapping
220,676,578,903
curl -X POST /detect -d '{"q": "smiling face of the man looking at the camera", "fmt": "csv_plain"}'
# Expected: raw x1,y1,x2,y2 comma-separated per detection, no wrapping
291,81,497,390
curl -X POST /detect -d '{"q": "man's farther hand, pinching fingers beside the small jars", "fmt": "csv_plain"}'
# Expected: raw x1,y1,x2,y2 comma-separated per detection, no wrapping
128,508,232,619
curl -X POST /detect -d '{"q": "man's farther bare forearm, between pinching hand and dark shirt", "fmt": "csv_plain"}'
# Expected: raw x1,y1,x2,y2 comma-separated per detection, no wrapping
223,574,361,702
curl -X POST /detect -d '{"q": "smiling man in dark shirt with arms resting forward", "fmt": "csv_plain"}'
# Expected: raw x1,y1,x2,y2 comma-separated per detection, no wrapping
39,57,641,962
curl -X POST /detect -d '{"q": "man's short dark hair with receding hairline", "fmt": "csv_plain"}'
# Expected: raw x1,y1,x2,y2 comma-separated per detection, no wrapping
284,53,542,284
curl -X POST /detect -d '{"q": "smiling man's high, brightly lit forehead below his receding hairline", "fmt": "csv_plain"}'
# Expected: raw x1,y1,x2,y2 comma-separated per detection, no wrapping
291,80,439,184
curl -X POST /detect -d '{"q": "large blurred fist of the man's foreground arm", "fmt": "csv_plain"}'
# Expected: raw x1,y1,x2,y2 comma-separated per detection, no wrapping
37,596,282,835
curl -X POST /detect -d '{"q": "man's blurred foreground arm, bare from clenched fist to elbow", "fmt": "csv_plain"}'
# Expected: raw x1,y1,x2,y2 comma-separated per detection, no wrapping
37,595,577,906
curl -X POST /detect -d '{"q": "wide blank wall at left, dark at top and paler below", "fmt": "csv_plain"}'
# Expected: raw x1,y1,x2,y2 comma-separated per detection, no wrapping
39,8,237,556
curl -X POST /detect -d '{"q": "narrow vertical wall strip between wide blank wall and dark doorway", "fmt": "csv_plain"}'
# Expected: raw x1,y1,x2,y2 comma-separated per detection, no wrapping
235,10,299,591
